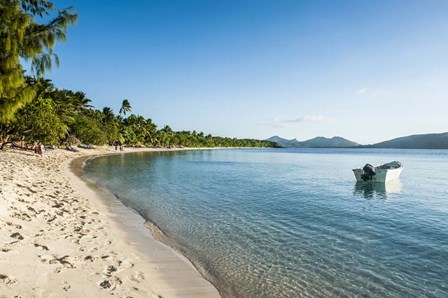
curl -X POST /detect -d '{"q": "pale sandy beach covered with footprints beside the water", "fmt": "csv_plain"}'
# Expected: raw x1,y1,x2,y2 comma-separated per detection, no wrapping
0,148,219,297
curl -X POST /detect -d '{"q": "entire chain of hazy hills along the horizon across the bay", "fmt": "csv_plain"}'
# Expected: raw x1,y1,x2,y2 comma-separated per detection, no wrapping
266,132,448,149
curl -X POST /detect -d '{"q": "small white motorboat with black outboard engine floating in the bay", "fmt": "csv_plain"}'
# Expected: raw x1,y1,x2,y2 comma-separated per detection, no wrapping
353,161,403,183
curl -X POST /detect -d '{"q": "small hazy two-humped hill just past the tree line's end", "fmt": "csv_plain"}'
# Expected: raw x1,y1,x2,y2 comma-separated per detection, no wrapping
267,136,359,148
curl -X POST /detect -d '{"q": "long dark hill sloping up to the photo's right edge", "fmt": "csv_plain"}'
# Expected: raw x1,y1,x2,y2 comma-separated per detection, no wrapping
362,132,448,149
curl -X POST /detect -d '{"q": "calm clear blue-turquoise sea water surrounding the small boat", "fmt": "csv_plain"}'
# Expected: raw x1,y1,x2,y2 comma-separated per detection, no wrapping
86,149,448,297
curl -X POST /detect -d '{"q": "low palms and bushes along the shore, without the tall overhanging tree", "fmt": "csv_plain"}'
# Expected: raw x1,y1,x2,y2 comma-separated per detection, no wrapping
0,78,273,147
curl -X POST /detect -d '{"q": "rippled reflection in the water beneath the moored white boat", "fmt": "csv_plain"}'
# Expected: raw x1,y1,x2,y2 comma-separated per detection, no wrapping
353,179,403,199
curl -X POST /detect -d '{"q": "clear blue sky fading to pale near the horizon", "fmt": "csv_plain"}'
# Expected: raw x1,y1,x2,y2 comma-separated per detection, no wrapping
41,0,448,144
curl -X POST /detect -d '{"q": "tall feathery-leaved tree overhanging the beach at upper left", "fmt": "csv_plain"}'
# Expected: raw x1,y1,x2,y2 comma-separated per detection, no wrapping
0,0,77,124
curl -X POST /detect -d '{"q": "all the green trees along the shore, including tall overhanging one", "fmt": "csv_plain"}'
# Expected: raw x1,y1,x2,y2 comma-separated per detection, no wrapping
0,0,273,148
